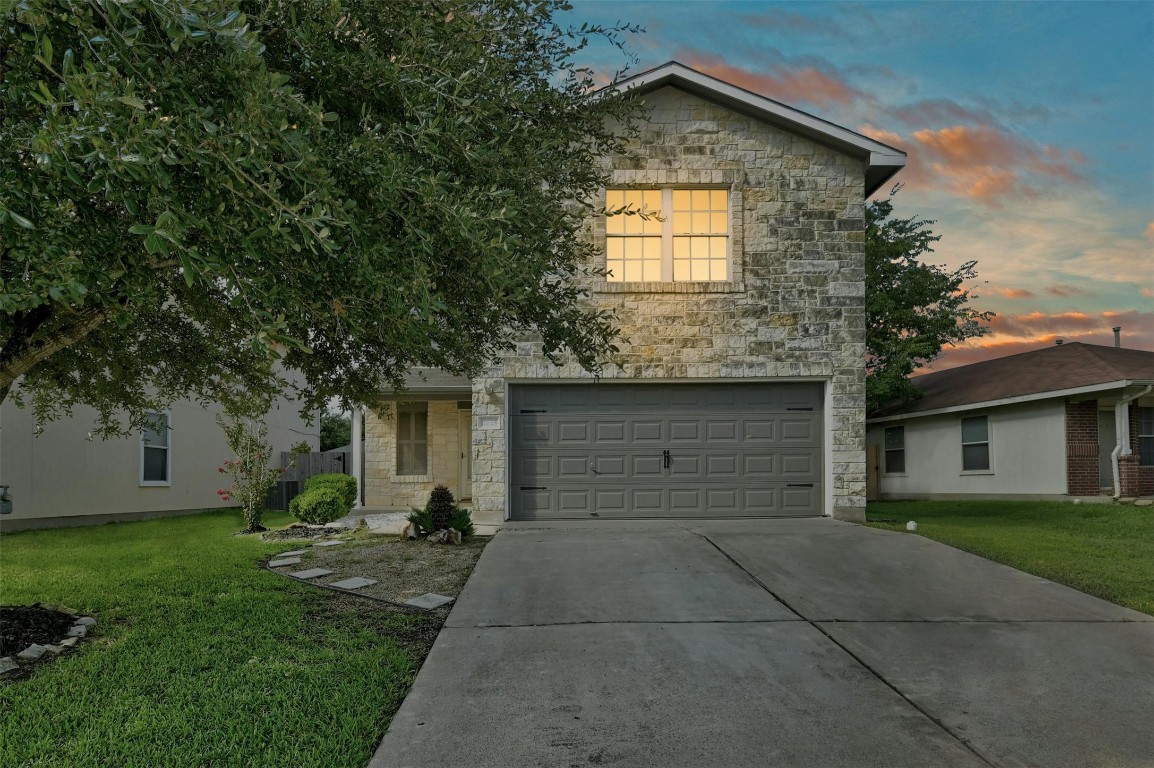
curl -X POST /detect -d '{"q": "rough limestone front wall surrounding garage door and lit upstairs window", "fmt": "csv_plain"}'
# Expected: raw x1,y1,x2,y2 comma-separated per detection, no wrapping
468,88,866,522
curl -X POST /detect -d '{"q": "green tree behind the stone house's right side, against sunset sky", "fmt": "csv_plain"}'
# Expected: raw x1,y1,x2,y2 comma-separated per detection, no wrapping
866,188,994,411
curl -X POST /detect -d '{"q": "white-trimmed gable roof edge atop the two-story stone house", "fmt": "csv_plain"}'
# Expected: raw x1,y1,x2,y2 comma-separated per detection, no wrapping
616,61,906,197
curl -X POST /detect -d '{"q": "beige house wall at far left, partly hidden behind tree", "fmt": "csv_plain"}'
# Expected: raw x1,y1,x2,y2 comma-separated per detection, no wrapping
0,392,320,530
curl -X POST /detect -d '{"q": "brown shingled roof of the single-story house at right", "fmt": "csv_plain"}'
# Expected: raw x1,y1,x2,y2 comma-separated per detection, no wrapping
870,342,1154,421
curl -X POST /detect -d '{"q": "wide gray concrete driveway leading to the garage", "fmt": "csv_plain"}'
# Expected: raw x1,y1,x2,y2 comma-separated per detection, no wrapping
370,519,1154,768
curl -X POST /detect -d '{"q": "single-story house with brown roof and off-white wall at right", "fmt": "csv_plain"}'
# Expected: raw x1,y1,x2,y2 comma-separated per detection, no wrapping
867,344,1154,499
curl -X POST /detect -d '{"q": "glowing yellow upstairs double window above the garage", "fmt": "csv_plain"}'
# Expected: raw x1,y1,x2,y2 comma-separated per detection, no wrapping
605,189,729,283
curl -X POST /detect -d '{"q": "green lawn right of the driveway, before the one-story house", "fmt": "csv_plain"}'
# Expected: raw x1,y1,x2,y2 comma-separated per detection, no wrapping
867,502,1154,615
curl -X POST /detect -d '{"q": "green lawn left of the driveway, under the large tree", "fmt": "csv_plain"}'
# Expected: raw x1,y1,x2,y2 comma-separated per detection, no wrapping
0,511,440,768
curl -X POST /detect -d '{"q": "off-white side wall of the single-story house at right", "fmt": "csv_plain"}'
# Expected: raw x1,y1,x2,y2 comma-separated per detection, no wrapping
867,399,1066,498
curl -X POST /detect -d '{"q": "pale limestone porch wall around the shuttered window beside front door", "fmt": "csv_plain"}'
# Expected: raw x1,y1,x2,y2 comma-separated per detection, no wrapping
365,400,460,509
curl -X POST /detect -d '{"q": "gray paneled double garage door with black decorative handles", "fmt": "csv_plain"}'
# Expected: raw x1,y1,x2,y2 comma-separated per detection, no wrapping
509,383,822,520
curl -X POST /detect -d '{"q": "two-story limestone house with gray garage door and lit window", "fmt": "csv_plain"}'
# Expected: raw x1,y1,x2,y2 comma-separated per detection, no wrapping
354,63,906,524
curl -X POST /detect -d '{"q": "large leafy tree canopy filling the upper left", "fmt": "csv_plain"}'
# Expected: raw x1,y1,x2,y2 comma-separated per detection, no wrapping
0,0,636,434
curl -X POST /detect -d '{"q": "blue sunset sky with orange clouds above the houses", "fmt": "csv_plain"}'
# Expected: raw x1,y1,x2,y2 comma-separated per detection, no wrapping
567,0,1154,369
